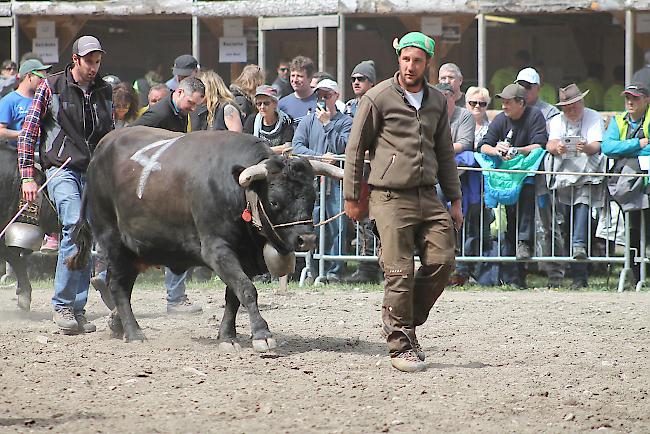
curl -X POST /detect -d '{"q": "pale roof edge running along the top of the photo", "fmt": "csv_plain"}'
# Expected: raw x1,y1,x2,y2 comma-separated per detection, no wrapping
5,0,650,17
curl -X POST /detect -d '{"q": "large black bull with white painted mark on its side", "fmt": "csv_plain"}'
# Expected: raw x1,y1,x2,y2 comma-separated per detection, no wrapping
69,127,342,351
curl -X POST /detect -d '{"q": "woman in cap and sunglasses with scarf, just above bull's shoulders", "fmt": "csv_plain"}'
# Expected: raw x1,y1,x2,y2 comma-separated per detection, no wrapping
244,85,293,147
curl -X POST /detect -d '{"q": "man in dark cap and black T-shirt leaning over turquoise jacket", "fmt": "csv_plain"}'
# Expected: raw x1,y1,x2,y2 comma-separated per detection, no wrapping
479,83,548,287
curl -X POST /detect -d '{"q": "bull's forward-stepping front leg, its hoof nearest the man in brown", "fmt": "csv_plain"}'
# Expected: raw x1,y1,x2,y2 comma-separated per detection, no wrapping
202,242,276,352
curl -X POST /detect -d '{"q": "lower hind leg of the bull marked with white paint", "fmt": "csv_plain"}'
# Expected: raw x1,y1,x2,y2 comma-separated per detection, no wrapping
109,252,146,342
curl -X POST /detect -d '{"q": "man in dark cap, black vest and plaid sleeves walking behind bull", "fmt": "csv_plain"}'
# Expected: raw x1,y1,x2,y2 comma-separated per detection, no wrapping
18,36,114,334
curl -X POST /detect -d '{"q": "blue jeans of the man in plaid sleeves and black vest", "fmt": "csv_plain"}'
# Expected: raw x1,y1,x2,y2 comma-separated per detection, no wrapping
45,167,92,312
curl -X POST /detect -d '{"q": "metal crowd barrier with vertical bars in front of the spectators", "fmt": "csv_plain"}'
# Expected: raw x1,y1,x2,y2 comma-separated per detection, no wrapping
299,156,650,292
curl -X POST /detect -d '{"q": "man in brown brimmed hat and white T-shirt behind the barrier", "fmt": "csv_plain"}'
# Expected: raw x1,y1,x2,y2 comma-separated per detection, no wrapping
545,84,605,289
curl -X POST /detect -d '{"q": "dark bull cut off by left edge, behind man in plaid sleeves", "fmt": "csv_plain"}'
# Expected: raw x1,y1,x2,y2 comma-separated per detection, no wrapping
0,145,59,310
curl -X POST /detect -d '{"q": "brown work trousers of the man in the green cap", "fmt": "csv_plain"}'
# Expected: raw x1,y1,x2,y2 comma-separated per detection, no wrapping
370,186,456,356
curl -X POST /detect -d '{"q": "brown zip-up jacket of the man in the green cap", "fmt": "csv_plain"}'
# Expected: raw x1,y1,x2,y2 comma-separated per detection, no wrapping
343,74,461,201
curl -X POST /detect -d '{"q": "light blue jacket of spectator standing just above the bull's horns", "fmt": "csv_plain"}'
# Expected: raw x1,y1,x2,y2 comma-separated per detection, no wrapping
291,111,352,155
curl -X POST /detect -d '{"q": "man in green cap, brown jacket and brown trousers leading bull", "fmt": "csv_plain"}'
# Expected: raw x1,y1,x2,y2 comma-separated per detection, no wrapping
343,32,463,372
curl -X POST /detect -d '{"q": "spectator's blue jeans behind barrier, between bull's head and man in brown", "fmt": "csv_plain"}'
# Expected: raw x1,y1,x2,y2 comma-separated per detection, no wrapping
314,179,347,277
